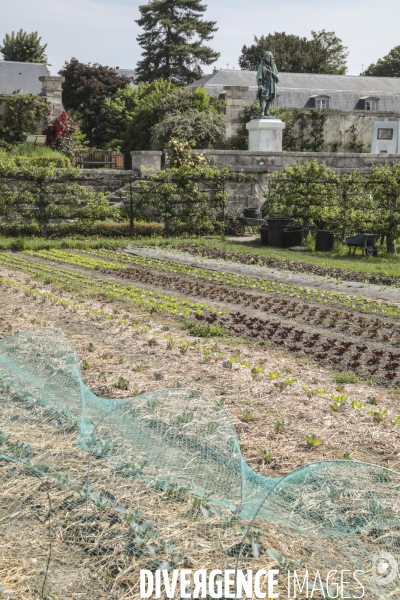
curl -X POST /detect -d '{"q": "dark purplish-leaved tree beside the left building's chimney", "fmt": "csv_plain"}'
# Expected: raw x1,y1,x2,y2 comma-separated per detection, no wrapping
59,58,129,145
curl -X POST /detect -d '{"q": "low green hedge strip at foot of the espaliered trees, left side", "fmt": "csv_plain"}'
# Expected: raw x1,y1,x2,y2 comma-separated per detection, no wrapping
0,221,164,238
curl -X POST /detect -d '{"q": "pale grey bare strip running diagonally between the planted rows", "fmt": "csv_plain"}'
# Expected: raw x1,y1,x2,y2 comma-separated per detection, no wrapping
123,246,400,304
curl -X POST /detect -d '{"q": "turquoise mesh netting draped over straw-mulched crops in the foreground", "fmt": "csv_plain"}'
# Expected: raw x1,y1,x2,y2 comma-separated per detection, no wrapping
0,329,400,599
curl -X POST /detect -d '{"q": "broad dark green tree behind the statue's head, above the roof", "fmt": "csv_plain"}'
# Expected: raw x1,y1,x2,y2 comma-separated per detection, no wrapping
239,29,348,75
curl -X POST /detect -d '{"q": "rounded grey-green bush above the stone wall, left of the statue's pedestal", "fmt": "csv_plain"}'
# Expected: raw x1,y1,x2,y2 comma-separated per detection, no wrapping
151,110,226,150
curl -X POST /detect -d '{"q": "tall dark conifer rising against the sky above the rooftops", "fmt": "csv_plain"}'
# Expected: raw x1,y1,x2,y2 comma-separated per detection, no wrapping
136,0,220,84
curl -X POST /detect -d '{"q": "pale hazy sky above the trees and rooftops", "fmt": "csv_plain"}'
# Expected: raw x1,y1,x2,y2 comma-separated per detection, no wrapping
0,0,400,75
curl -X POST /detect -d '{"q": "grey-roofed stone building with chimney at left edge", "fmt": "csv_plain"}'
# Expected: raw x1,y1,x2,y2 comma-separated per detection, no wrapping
0,60,64,115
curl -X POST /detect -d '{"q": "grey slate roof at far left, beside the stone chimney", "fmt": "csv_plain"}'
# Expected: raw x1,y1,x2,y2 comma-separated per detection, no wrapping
0,60,50,95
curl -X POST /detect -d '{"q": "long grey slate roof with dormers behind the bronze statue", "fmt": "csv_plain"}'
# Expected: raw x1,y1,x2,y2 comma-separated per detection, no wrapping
188,69,400,112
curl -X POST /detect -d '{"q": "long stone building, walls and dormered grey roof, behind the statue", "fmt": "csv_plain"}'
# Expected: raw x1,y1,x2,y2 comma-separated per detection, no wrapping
189,69,400,151
